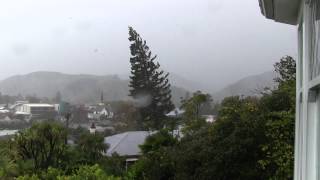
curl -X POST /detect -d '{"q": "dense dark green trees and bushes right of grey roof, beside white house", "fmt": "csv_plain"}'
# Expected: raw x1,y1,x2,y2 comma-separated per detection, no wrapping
129,57,295,180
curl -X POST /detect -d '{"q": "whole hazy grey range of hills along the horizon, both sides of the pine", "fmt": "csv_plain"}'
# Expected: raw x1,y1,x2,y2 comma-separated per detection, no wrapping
0,71,275,105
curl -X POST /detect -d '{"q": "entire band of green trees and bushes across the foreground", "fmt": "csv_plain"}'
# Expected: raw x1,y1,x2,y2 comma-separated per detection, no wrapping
0,55,295,180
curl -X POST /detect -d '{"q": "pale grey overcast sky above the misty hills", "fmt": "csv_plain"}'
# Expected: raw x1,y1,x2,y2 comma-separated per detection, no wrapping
0,0,297,88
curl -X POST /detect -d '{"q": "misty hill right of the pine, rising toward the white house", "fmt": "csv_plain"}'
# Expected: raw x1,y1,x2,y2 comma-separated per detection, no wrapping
213,71,276,101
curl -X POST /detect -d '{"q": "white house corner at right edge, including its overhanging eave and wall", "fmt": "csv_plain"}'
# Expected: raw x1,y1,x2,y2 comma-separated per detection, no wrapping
259,0,320,180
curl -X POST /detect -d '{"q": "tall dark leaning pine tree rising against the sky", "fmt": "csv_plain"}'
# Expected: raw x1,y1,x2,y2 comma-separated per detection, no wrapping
129,27,174,129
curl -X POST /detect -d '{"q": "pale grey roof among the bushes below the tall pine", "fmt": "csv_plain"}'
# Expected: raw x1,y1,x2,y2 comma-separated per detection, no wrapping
104,131,150,156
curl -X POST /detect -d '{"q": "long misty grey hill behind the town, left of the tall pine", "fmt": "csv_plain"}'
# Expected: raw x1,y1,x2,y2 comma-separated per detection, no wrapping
0,71,187,103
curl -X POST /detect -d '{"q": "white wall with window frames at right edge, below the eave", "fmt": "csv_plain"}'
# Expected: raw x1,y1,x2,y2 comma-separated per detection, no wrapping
294,1,320,180
